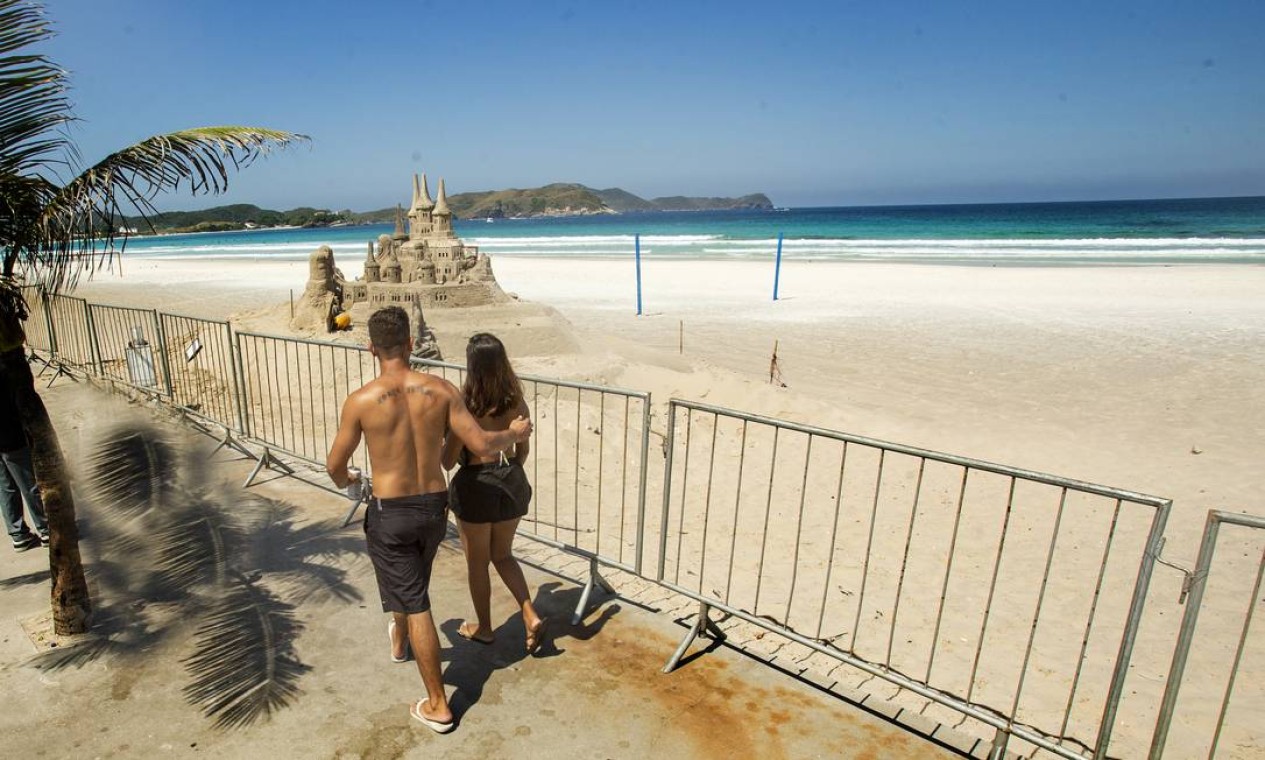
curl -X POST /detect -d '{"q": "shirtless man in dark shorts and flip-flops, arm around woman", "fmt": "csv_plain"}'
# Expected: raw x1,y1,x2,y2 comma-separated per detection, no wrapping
325,306,531,733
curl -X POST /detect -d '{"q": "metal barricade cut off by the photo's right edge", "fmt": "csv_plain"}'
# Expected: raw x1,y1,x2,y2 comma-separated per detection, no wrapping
1149,510,1265,760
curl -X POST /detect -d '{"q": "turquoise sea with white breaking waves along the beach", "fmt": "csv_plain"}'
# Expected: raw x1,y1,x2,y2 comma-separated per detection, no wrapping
118,197,1265,264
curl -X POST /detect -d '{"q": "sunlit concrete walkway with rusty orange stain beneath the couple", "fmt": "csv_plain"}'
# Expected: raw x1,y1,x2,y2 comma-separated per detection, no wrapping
0,381,958,759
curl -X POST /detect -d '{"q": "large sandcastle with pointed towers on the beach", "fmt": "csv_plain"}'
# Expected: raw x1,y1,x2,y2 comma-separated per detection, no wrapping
291,175,507,348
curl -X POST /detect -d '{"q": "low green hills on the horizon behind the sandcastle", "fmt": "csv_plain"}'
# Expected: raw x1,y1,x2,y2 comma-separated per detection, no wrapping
133,182,773,234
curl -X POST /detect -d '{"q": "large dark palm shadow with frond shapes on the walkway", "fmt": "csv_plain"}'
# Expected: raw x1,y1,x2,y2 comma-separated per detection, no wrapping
51,425,362,728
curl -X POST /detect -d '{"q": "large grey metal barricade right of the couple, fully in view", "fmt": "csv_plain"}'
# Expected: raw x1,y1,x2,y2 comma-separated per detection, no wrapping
655,400,1170,757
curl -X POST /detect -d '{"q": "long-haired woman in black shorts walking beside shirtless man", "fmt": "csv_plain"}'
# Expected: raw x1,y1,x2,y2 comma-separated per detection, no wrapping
444,333,545,653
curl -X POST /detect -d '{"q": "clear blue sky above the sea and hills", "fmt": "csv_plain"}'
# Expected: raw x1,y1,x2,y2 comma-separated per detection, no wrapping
46,0,1265,211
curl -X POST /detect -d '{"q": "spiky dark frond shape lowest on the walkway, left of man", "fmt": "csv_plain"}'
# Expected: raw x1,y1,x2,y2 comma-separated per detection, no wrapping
185,582,310,728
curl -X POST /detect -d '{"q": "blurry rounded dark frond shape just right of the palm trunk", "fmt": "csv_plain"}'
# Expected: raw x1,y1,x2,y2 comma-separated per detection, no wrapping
87,425,181,520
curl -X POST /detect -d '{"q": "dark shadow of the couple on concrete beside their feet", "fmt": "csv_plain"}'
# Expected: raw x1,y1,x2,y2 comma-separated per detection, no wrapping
439,580,620,721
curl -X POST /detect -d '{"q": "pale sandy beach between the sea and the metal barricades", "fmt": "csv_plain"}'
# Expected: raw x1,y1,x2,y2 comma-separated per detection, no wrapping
54,251,1265,757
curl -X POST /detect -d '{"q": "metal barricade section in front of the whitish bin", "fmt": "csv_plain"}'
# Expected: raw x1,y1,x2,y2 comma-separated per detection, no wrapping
87,303,171,397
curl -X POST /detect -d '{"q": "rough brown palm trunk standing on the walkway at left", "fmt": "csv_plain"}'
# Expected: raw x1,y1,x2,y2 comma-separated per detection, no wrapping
0,346,92,636
